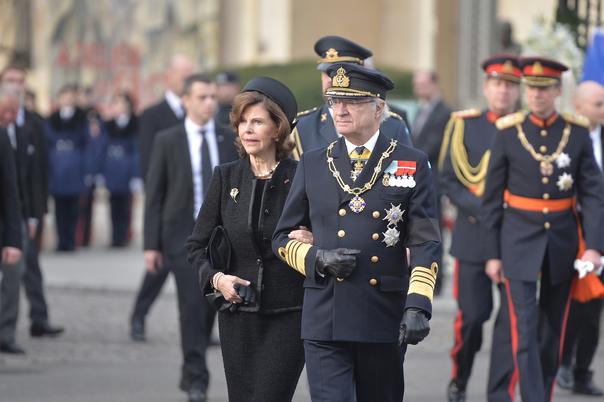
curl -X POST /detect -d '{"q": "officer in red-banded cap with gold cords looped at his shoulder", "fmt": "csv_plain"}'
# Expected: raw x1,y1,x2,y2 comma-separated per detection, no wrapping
439,55,522,402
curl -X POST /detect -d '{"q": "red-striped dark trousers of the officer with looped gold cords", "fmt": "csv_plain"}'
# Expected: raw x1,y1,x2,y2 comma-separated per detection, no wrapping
451,260,514,401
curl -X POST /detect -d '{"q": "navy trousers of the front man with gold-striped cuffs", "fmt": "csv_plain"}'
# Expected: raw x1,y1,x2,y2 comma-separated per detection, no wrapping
304,340,406,402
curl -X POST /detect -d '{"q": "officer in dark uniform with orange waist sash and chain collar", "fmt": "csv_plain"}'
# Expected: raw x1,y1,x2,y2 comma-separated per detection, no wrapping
483,57,604,402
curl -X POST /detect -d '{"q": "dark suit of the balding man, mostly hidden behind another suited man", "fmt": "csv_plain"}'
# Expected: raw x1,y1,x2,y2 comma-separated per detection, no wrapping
132,98,182,320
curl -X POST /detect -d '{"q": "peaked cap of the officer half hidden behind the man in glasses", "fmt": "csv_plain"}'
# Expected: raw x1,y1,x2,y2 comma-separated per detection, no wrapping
315,35,373,71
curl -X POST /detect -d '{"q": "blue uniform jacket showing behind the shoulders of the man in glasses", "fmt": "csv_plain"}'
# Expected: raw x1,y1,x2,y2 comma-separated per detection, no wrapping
292,105,411,159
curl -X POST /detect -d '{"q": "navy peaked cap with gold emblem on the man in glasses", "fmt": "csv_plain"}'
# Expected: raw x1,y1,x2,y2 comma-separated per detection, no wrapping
325,63,394,99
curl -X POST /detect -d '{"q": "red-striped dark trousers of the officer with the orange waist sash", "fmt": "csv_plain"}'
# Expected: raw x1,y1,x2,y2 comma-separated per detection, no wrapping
506,260,571,402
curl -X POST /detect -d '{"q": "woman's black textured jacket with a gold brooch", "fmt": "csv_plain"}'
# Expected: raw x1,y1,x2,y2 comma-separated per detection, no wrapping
186,157,304,313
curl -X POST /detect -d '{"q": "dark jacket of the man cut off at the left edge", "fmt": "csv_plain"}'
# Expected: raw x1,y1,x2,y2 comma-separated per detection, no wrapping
0,132,22,250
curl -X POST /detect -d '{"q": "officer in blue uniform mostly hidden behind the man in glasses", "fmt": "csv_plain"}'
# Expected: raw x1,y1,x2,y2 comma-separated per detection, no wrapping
292,35,411,159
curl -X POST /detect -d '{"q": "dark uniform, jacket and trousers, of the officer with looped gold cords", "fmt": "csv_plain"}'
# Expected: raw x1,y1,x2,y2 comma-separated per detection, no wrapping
439,109,514,402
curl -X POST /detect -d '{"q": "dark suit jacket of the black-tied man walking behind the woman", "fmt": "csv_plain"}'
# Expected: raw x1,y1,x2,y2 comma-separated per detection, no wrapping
144,123,237,255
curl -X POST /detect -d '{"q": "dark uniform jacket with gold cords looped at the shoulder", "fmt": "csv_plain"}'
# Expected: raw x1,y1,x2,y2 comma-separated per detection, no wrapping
439,109,497,263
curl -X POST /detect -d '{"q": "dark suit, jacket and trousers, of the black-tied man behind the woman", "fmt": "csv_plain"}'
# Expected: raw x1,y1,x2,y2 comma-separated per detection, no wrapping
144,124,236,390
